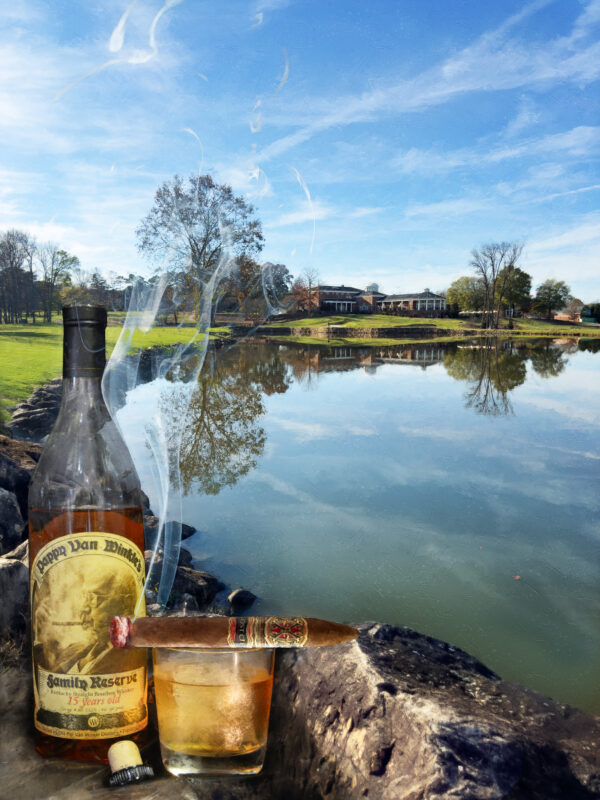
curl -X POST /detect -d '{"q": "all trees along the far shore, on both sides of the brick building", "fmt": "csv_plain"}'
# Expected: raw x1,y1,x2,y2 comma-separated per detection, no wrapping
0,175,600,328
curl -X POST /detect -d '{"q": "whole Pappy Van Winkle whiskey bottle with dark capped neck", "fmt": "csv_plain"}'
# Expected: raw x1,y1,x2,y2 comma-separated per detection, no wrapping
29,306,148,763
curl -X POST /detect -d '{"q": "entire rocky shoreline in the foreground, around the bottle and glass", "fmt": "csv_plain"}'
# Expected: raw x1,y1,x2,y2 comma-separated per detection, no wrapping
0,381,600,800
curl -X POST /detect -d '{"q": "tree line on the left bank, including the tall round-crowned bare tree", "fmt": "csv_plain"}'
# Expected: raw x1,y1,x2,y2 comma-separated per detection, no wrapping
0,175,293,324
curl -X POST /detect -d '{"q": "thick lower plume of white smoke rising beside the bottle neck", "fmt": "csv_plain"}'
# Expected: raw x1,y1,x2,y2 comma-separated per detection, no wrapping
102,229,292,609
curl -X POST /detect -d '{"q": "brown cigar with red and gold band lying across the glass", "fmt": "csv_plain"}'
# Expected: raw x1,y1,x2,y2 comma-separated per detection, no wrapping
109,617,358,648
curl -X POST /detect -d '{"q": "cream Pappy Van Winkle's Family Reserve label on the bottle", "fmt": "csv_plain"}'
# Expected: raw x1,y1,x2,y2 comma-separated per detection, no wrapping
31,532,148,739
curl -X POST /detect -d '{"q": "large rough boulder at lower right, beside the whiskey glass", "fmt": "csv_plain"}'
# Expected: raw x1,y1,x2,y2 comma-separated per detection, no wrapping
271,623,600,800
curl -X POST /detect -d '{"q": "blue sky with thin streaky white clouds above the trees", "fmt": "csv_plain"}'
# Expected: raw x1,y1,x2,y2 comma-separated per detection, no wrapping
0,0,600,302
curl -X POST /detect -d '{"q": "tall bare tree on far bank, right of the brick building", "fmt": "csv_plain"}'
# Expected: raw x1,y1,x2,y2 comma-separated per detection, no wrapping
471,242,523,328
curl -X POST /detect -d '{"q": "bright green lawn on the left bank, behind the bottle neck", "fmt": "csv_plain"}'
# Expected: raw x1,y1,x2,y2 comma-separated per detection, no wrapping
0,317,228,418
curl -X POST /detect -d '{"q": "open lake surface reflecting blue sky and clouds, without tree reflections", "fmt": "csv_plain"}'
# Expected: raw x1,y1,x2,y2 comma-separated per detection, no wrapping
173,346,600,711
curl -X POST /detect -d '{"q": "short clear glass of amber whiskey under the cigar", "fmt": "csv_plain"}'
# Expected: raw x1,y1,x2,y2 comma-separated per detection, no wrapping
152,648,273,775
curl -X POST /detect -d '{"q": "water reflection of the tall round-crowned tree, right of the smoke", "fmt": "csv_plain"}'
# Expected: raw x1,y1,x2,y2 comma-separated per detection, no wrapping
180,346,289,494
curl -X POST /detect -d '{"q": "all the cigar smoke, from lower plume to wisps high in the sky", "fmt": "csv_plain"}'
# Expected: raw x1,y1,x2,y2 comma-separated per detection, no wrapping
77,0,315,620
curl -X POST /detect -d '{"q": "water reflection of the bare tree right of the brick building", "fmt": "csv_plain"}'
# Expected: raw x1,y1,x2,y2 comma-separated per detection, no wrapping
444,339,527,416
